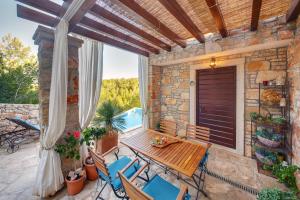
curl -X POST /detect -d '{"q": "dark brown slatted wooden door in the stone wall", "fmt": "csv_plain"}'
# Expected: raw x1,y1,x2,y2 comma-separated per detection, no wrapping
196,66,236,149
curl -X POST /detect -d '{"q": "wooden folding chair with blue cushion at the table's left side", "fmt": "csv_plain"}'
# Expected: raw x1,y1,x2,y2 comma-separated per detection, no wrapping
89,147,140,199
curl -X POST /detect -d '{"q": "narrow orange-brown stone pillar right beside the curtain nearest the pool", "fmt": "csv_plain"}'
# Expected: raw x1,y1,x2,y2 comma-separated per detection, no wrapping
148,65,161,129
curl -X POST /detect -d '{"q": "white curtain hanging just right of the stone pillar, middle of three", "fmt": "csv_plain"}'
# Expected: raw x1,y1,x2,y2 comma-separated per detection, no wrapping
79,39,103,159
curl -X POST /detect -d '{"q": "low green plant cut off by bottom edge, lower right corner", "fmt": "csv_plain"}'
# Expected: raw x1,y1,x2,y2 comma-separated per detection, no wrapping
257,188,297,200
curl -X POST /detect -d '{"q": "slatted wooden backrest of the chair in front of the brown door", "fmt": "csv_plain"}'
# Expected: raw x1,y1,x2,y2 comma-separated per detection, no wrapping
186,124,210,143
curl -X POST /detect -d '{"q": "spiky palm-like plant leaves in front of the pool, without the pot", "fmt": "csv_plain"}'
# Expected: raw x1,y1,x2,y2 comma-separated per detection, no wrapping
93,101,126,132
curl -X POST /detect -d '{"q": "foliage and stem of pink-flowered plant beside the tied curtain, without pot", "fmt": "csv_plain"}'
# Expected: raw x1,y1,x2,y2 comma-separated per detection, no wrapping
54,131,80,170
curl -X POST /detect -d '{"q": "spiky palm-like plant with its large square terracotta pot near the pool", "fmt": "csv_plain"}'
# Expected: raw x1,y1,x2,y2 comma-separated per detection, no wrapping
93,101,126,154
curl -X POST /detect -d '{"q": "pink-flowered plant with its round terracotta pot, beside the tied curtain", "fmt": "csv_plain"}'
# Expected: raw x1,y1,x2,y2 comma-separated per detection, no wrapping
55,131,85,195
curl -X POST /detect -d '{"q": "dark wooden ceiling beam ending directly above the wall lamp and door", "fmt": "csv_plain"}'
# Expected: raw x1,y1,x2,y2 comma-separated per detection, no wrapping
206,0,228,38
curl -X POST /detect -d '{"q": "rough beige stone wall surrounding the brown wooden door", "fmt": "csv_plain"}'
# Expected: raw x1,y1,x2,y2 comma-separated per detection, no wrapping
149,18,296,156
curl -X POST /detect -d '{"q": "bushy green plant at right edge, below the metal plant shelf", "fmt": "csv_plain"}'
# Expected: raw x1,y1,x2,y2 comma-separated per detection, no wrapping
272,162,300,192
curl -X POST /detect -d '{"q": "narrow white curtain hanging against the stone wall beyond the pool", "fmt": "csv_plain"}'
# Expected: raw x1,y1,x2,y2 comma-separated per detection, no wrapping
138,55,149,129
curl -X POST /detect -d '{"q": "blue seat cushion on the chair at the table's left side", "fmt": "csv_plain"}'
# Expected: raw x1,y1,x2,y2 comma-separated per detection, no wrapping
98,156,140,190
